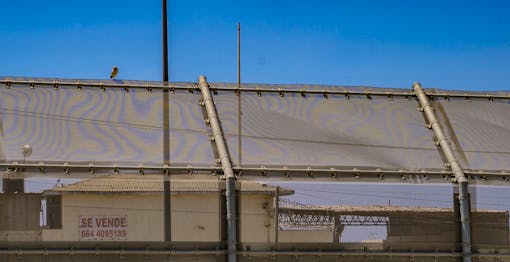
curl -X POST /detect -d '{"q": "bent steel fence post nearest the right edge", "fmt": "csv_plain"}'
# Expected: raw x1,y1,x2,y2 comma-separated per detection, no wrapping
413,82,471,262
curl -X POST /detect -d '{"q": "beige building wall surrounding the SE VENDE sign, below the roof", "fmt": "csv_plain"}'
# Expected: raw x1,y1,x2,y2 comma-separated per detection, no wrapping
42,190,290,244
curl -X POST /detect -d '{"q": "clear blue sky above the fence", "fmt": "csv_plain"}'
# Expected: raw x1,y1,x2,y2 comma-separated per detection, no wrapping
0,0,510,90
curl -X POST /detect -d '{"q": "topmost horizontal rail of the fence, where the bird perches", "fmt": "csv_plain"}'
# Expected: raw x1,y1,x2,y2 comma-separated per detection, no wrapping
0,77,510,102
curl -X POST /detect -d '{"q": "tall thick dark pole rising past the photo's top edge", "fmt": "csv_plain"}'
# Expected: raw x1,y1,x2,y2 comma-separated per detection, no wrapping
162,0,172,241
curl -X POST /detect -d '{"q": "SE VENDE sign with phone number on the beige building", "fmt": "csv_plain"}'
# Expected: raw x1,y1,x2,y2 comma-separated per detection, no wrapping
80,216,128,240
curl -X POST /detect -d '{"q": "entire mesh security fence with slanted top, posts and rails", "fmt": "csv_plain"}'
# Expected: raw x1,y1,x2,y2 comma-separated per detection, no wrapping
0,75,510,261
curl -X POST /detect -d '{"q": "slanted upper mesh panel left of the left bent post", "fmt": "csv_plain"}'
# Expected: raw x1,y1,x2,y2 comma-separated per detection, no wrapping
0,79,214,166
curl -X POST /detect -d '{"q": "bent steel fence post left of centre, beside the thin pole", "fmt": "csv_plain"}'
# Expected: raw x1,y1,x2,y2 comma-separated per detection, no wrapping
198,76,237,262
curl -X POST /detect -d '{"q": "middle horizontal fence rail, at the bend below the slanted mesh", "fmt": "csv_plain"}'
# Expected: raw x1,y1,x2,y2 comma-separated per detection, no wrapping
0,162,510,186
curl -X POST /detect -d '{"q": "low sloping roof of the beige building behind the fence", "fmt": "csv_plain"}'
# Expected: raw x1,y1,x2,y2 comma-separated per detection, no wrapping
45,174,294,195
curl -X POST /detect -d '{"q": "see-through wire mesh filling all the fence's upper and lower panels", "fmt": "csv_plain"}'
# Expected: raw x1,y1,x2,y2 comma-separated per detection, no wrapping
0,77,510,254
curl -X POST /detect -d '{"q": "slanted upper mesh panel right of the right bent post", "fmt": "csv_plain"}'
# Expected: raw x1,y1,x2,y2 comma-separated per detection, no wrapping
435,95,510,170
